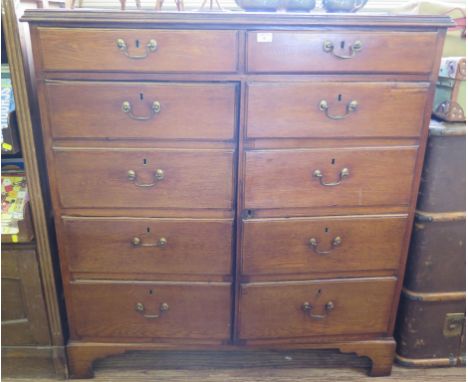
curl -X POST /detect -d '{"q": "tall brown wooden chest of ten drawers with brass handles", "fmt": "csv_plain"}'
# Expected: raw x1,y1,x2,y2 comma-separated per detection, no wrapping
25,10,450,377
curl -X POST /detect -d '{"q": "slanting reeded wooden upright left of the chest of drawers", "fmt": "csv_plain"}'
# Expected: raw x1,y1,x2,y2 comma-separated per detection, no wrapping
2,0,65,358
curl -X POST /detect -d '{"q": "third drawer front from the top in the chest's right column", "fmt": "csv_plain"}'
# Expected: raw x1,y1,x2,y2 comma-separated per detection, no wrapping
244,146,417,209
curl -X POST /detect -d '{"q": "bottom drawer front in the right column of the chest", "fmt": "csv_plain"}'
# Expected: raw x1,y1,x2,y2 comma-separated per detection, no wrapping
239,277,396,340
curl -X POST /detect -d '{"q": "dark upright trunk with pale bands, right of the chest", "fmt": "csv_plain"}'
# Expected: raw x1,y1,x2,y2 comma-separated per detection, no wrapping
395,121,466,367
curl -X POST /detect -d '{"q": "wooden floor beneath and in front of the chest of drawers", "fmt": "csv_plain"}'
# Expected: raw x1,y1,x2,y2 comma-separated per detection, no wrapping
2,350,466,382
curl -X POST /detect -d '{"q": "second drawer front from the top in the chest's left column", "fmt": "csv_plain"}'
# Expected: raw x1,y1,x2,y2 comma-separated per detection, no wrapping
45,81,236,140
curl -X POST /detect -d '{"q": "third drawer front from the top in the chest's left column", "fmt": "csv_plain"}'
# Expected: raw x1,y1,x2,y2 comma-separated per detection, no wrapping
54,149,234,209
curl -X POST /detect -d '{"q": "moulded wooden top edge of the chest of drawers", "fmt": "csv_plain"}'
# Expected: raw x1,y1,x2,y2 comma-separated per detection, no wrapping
21,9,453,29
